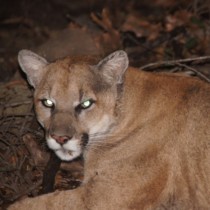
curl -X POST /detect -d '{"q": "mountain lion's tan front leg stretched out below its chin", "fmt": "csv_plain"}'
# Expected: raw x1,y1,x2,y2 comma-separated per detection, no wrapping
8,187,85,210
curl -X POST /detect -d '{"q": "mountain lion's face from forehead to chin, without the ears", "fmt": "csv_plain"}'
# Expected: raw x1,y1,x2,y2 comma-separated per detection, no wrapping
35,61,116,160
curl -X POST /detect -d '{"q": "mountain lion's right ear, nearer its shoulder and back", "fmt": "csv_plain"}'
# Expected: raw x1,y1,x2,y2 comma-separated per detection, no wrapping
97,50,129,84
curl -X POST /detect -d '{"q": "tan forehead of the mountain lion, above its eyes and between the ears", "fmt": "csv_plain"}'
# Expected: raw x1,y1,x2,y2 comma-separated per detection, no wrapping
37,57,100,99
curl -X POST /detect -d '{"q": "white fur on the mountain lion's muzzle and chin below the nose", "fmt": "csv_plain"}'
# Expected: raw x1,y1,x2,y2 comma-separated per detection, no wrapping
47,137,82,161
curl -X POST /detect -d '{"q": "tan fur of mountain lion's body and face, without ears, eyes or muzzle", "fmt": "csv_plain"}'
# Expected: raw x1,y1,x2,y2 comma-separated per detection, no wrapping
9,50,210,210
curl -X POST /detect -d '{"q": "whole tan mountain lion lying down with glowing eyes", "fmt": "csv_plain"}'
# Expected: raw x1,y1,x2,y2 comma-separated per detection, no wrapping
9,50,210,210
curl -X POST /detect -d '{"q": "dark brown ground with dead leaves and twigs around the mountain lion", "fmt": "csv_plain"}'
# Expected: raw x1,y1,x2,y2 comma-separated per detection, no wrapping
0,0,210,209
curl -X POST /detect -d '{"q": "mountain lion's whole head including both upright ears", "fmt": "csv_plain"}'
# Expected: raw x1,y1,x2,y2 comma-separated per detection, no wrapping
19,50,128,160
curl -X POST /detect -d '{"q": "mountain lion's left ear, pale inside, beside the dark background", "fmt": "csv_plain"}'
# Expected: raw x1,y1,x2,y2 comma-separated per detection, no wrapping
18,50,48,88
